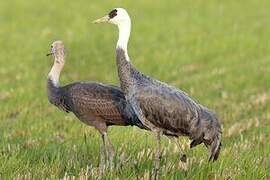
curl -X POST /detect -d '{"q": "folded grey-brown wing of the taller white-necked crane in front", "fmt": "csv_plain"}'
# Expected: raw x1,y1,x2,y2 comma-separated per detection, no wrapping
134,86,199,135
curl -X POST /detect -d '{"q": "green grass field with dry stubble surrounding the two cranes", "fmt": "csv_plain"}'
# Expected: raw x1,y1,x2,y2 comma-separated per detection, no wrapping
0,0,270,179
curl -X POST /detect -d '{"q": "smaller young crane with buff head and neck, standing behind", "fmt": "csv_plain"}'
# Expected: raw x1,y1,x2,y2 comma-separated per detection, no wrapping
47,41,147,172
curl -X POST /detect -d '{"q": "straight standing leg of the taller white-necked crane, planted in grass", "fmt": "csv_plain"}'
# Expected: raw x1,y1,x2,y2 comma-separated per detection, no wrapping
152,131,161,180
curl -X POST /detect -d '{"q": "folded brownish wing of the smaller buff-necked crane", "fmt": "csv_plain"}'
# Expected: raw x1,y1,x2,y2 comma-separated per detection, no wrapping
63,83,126,122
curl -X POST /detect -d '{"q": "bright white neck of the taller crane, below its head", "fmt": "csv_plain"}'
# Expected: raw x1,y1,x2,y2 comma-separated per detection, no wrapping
116,20,131,61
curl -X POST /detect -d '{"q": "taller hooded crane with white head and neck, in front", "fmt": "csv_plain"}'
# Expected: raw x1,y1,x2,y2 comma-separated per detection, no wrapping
93,8,222,176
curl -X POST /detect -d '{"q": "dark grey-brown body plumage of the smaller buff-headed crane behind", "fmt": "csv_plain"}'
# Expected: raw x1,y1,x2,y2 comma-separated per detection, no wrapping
47,79,148,128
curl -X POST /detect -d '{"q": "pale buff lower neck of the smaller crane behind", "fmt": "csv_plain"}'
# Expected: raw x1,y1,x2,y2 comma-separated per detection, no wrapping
48,57,64,86
